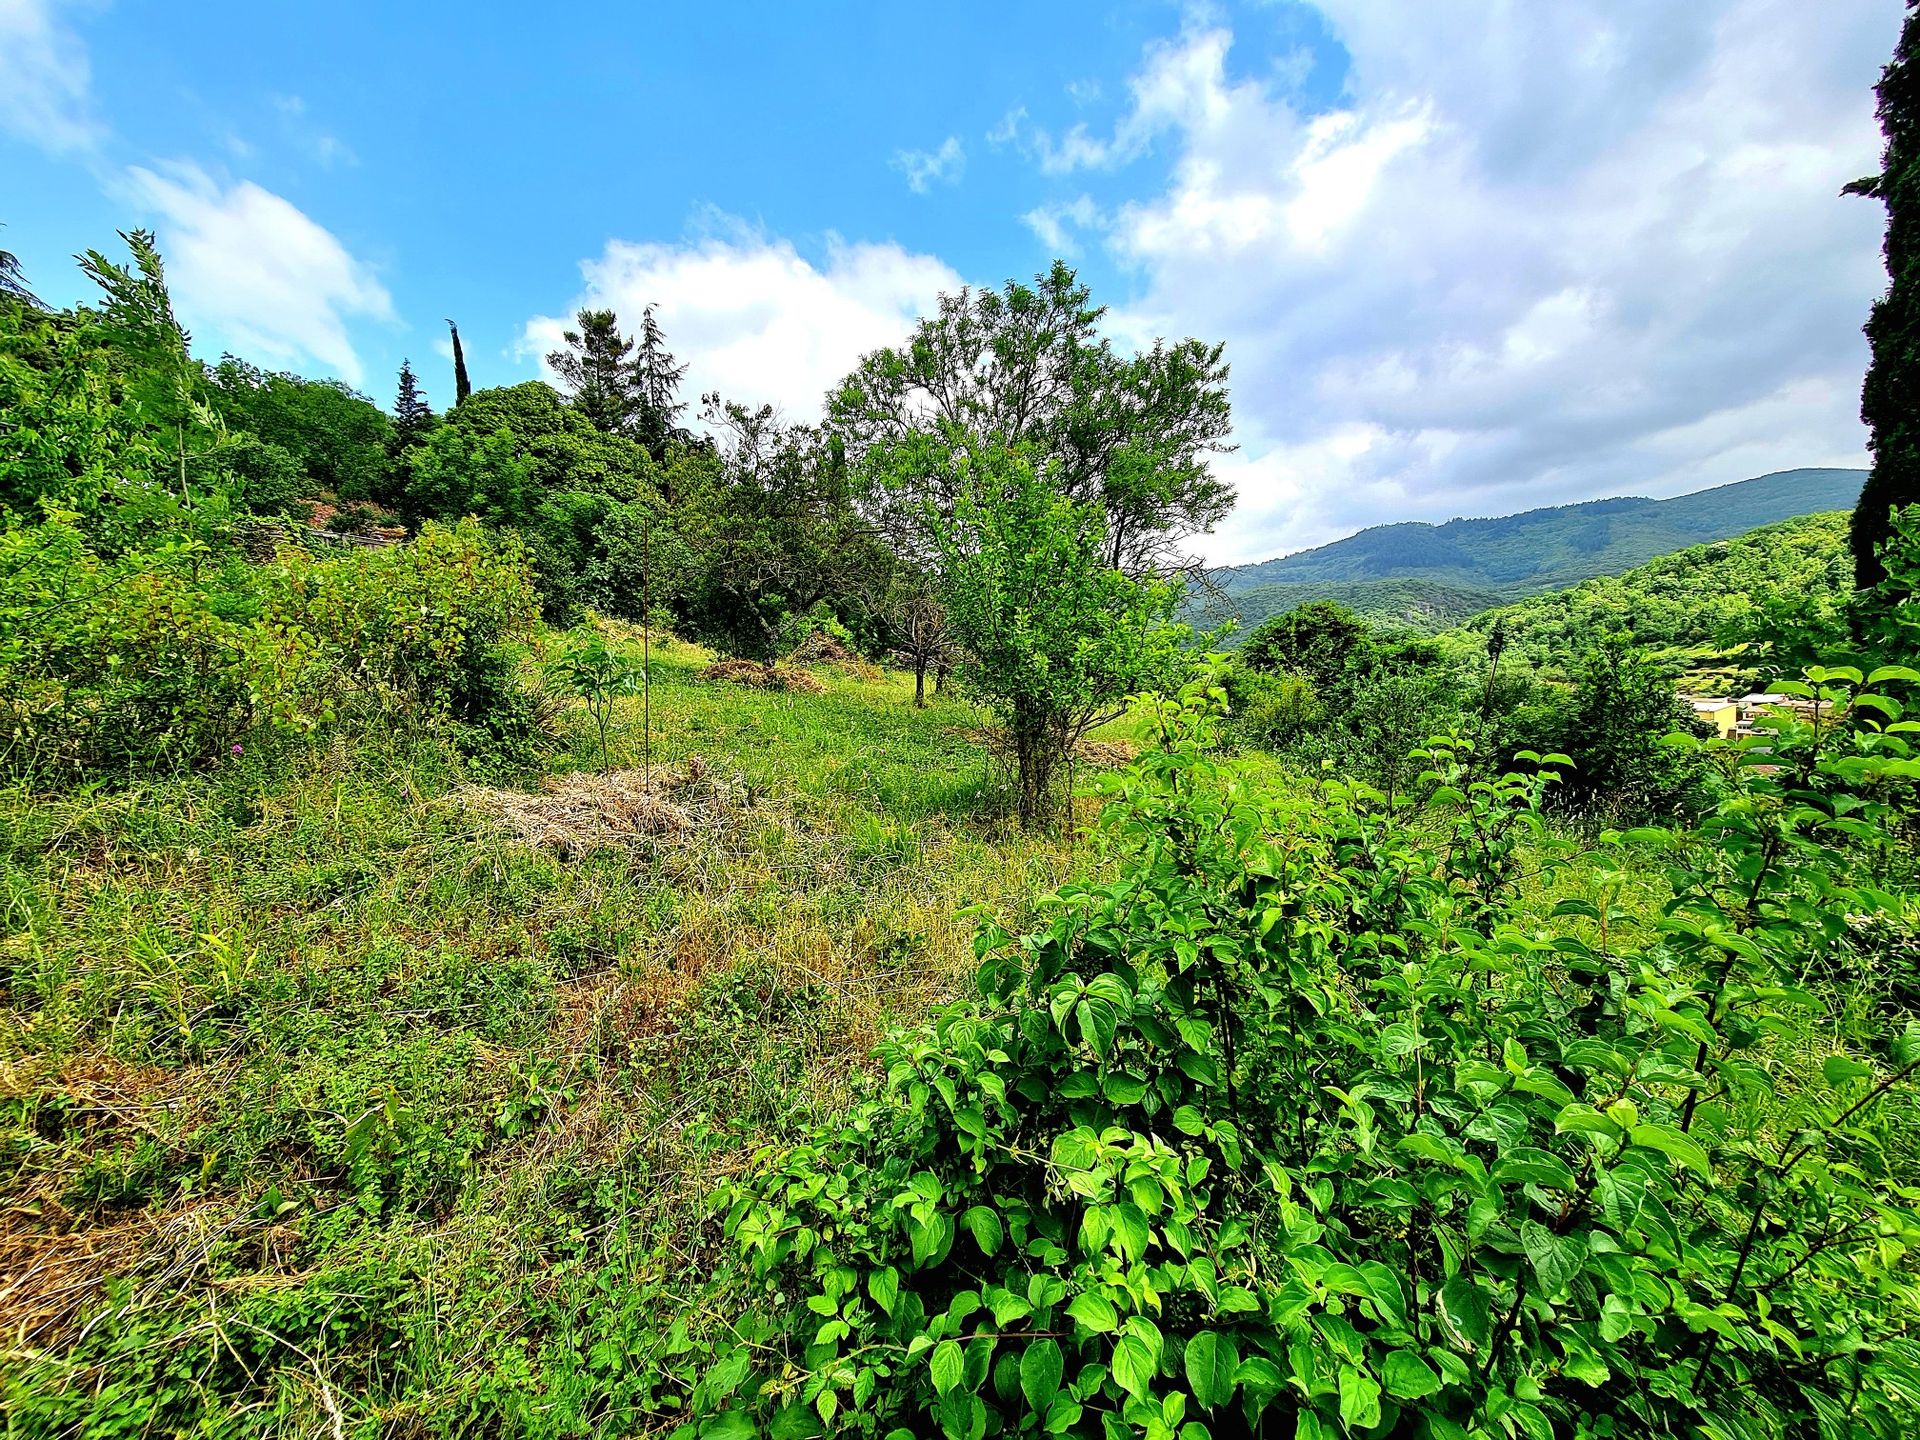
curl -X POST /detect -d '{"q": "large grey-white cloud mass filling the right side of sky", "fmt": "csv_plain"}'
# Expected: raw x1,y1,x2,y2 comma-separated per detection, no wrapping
1067,0,1899,561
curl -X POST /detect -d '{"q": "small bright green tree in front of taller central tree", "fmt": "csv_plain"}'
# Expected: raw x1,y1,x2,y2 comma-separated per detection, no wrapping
939,440,1190,826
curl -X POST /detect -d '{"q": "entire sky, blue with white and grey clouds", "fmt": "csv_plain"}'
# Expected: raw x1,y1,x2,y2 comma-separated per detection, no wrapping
0,0,1901,561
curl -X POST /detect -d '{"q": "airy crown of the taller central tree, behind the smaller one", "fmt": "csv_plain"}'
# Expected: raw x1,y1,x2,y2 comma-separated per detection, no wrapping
828,261,1233,576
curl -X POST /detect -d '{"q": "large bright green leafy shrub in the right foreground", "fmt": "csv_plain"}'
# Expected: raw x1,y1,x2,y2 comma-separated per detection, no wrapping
682,668,1920,1440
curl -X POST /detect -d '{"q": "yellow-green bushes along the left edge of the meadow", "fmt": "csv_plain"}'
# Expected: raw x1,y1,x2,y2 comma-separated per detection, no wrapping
0,513,534,778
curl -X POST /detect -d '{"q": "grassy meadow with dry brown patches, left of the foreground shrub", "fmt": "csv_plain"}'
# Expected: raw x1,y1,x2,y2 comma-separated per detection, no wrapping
0,643,1113,1434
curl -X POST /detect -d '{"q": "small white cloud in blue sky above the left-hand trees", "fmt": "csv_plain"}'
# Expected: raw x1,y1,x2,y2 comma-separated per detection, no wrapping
127,165,394,386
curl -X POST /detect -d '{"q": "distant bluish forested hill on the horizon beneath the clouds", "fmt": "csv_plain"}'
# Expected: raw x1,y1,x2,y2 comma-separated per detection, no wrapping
1215,470,1866,602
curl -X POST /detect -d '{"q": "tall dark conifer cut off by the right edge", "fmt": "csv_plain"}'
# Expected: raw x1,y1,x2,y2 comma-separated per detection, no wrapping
1847,0,1920,589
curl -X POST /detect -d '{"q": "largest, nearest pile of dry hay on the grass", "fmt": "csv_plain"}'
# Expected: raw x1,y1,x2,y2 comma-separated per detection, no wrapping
455,756,732,854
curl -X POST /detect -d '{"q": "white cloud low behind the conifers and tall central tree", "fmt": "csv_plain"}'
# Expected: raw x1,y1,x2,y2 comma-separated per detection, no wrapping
520,213,962,420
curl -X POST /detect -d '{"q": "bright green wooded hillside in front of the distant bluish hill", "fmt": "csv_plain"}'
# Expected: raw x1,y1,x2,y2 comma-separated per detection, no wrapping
1450,513,1853,674
